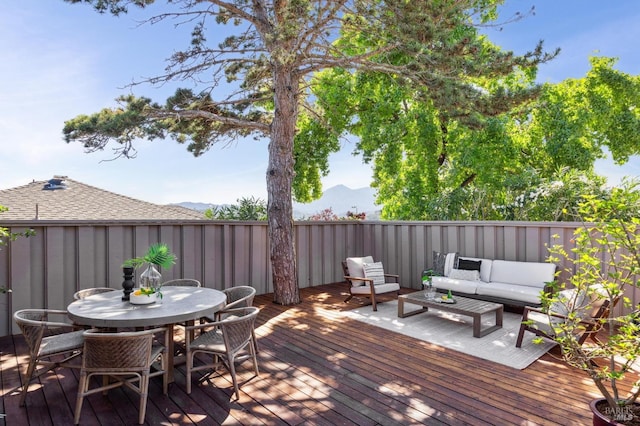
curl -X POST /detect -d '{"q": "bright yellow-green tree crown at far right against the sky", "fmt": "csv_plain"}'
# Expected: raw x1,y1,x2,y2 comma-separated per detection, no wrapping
530,57,640,170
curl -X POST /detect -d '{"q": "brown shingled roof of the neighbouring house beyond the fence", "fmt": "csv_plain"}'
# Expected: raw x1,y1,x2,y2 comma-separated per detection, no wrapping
0,176,205,221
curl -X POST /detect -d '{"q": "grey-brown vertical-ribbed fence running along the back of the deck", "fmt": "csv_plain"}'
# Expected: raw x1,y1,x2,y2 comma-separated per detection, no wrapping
0,221,635,336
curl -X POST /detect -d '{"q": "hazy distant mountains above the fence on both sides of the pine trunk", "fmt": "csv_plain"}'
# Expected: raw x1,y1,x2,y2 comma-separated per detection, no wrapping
171,185,381,219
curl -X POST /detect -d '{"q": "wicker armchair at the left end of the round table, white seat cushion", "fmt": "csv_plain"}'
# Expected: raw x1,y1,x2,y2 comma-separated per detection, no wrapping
13,309,83,407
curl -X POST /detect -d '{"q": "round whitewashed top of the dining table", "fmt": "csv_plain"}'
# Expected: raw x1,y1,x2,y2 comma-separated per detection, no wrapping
67,286,227,328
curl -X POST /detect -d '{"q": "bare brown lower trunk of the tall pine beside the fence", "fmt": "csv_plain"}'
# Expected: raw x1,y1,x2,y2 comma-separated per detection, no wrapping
267,65,300,305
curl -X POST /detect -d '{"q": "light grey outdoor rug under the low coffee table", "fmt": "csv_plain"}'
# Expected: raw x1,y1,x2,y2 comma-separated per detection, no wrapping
344,300,555,370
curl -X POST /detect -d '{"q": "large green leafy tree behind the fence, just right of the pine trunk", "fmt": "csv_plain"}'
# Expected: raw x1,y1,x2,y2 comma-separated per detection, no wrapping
296,37,553,220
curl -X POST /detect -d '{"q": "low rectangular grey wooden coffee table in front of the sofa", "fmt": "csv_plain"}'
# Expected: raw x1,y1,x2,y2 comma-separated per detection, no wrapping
398,290,504,337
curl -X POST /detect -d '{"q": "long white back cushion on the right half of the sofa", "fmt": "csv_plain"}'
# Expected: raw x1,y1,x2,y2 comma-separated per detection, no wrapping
490,260,556,290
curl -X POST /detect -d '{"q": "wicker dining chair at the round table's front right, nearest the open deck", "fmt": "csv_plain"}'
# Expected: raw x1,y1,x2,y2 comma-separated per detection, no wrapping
186,306,260,399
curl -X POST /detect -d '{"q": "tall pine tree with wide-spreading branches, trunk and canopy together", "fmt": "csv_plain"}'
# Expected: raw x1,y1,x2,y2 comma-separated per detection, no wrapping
63,0,548,304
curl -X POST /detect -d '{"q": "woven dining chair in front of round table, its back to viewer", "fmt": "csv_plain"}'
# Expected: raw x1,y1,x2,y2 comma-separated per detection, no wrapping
74,327,169,425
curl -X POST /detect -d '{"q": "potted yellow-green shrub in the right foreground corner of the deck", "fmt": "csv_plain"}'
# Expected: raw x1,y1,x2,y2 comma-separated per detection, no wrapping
537,180,640,425
